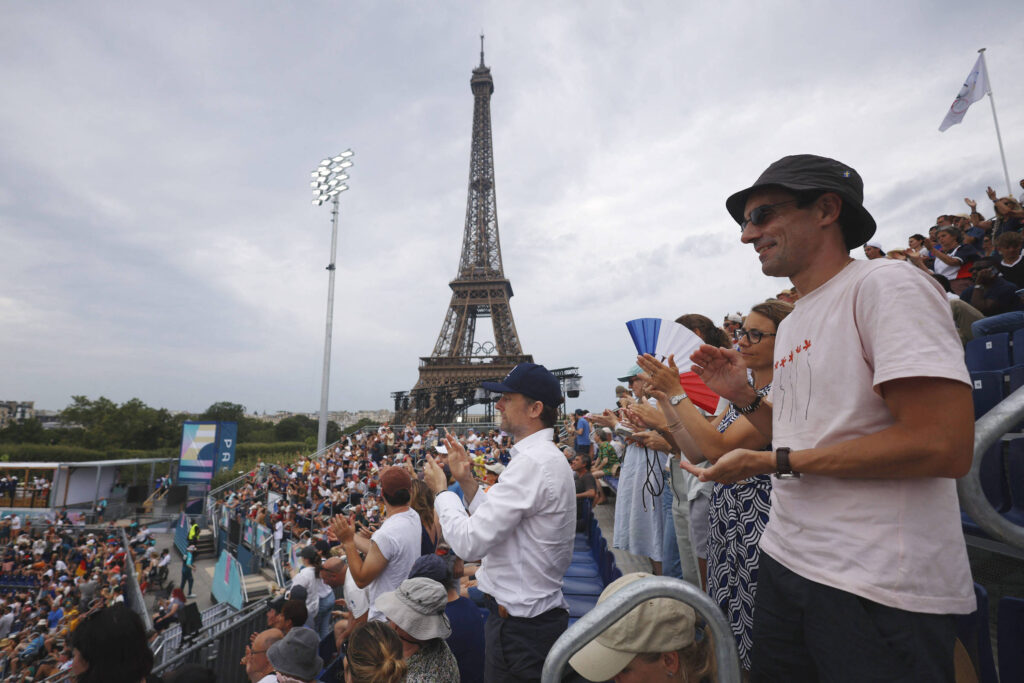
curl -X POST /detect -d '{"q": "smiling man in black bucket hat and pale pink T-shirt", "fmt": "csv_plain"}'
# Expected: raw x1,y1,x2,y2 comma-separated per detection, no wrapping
683,155,975,681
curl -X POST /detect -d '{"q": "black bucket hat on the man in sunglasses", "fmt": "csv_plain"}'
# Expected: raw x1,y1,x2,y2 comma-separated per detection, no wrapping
725,155,876,249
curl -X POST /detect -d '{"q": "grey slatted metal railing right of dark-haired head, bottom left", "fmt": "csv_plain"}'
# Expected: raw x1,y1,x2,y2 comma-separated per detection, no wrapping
153,600,267,683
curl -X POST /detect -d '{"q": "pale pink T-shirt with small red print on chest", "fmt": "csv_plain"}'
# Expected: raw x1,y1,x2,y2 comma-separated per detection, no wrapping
761,259,975,613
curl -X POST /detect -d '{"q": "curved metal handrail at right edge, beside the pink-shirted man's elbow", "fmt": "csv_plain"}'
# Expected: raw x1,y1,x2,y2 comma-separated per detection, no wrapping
956,387,1024,550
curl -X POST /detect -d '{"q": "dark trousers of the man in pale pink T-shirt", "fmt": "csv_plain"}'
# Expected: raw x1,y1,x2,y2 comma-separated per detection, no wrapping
751,553,956,683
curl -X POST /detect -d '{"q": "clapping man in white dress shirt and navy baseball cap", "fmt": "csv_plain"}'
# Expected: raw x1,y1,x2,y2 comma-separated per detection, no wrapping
424,362,575,682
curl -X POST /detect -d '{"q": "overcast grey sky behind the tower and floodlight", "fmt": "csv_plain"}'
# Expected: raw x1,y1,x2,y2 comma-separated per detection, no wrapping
0,0,1024,412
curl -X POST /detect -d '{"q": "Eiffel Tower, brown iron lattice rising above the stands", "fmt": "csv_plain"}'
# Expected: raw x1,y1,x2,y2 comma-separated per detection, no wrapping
391,36,534,423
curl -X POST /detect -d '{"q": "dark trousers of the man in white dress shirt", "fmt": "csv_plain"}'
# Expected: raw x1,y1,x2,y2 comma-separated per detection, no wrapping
483,596,569,683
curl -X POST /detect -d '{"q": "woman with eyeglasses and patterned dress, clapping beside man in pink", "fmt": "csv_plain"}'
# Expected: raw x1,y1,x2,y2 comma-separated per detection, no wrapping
634,300,793,670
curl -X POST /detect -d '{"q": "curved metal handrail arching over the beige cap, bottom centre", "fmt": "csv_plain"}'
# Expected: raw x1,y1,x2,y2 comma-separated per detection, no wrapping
541,577,741,683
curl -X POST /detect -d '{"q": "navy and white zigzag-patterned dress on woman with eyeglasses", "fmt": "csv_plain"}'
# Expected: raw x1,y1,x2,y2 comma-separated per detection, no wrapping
708,384,771,670
